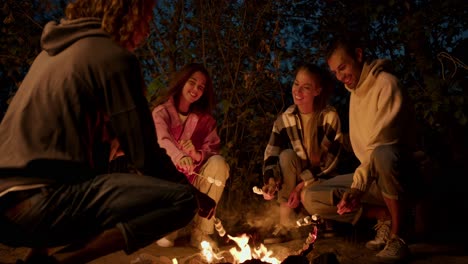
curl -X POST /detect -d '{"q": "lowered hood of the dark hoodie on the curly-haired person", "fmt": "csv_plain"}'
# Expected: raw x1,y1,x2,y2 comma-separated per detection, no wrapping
41,18,110,56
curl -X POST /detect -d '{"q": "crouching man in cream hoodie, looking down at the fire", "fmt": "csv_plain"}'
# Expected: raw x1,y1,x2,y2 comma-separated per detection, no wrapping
304,33,417,260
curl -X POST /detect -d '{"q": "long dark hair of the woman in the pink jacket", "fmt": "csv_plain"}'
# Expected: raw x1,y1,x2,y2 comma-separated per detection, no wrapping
153,63,214,114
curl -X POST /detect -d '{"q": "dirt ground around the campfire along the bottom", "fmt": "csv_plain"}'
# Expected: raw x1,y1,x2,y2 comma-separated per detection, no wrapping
0,197,468,264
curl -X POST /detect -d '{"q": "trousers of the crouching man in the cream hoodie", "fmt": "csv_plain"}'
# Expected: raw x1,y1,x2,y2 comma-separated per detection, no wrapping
301,145,415,224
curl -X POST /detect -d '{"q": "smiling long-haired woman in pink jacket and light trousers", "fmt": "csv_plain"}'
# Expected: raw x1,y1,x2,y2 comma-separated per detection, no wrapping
152,63,229,247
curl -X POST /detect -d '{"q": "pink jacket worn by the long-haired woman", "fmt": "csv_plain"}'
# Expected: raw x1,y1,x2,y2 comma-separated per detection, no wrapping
153,98,220,182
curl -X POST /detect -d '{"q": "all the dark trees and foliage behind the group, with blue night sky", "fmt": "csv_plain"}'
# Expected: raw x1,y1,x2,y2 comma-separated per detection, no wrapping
0,0,468,227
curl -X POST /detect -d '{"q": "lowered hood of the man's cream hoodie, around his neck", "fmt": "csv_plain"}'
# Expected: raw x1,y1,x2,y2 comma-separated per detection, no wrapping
345,59,393,95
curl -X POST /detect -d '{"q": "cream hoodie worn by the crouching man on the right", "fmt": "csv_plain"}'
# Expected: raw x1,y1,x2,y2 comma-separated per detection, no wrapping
346,60,406,191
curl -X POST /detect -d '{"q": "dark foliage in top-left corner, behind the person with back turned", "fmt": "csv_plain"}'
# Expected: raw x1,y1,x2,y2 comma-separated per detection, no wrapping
0,0,63,117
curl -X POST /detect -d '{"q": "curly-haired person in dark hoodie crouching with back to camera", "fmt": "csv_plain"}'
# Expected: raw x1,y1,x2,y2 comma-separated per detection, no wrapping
0,0,215,263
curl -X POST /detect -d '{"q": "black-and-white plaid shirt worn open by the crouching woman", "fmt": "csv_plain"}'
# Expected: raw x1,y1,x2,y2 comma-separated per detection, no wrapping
263,105,342,183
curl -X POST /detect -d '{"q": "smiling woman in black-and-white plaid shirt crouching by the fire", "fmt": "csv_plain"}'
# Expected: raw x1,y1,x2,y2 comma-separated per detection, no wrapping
262,64,342,244
